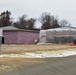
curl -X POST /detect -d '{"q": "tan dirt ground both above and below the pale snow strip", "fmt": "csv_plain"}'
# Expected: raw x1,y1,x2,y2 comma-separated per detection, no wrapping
0,44,76,73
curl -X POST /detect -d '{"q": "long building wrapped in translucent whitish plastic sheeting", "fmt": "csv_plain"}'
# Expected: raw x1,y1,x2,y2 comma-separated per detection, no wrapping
39,27,76,44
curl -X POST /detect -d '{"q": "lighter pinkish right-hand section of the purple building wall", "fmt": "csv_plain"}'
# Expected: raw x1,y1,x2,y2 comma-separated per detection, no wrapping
18,31,39,44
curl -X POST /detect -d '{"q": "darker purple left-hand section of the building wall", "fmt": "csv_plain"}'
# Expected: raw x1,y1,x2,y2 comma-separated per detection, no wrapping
3,31,18,44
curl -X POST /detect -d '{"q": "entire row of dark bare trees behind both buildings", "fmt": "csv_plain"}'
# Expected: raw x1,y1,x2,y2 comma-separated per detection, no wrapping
0,10,71,29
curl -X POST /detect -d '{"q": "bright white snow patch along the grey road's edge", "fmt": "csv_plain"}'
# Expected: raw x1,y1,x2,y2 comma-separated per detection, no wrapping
26,51,76,58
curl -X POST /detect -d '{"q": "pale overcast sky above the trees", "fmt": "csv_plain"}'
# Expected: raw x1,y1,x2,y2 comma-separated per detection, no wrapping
0,0,76,27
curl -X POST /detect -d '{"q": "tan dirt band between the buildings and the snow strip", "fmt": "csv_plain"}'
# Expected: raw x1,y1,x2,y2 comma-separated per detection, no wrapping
1,44,76,54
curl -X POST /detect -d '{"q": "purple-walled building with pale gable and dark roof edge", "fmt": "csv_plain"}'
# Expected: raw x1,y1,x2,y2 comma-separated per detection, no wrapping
0,26,39,44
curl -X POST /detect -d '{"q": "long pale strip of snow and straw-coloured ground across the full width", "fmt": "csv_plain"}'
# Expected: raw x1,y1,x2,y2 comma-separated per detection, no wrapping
0,50,76,58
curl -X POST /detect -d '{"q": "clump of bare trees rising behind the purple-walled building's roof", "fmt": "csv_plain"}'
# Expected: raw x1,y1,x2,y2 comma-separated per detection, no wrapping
14,15,36,29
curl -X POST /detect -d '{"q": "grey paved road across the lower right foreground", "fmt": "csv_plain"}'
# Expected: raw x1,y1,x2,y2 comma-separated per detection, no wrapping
0,56,76,75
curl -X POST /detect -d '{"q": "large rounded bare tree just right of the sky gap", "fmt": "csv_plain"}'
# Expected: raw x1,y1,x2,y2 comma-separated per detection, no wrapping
39,12,59,29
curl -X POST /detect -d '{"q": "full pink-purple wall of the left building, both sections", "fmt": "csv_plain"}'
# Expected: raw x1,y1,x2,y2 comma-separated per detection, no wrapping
3,31,39,44
